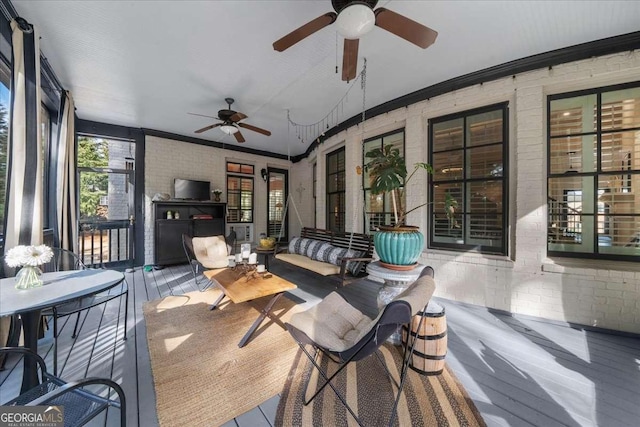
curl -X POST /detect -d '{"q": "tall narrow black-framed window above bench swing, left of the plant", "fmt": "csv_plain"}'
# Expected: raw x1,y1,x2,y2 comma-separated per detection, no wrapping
327,147,346,231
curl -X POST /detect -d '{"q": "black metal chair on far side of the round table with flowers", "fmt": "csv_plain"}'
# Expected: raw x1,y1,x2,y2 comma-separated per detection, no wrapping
42,248,129,375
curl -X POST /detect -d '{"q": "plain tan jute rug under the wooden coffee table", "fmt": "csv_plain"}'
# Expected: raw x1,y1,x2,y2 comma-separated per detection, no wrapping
143,289,300,427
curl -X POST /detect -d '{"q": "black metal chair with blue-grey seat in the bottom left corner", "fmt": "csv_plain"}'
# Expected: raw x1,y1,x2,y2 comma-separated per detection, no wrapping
0,347,127,427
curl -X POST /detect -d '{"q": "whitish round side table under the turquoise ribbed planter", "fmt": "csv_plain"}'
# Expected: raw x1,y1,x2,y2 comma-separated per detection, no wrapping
367,261,425,345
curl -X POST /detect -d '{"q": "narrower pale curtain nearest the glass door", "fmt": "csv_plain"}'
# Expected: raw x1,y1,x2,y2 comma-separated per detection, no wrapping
52,91,78,253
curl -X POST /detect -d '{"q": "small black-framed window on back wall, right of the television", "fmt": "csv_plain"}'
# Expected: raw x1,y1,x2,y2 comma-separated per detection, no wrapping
227,162,255,223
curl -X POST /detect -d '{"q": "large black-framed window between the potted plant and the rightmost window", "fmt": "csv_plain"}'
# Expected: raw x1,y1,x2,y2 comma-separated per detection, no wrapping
429,103,509,254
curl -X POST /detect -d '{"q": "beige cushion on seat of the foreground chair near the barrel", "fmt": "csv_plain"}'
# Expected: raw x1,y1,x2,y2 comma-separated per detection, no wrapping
289,292,374,351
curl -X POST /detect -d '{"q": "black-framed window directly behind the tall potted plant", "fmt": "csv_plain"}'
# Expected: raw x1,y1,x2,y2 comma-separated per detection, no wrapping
358,129,402,233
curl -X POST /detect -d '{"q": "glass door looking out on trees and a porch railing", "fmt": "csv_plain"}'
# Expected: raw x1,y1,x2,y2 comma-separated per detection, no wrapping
77,135,135,267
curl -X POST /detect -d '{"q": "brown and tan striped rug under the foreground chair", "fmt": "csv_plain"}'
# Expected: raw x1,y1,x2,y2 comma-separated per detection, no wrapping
276,344,485,427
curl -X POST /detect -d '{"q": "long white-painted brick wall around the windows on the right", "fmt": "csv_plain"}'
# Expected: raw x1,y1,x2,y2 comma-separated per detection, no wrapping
295,51,640,333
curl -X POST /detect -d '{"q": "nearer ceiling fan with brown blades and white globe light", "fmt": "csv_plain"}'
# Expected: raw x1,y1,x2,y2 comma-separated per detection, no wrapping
273,0,438,81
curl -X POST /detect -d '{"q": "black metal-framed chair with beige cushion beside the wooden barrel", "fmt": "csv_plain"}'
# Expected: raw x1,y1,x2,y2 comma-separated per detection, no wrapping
285,267,435,425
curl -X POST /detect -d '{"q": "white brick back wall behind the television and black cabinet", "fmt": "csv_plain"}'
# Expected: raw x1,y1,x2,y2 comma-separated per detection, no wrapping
144,136,290,264
